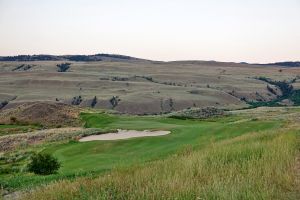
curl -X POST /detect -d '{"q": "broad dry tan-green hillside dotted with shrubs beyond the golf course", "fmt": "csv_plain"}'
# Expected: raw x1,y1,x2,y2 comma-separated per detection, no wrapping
0,59,300,115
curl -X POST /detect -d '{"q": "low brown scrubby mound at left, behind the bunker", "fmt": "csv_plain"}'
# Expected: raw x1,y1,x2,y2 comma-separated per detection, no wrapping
0,102,80,127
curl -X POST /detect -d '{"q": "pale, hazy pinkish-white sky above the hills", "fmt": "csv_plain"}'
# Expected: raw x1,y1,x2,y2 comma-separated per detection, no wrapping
0,0,300,63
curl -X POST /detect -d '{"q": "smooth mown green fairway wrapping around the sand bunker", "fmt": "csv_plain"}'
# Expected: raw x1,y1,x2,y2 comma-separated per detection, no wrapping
48,114,280,173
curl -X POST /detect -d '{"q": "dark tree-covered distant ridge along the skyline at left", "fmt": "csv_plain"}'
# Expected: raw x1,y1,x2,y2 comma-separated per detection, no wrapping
0,54,143,62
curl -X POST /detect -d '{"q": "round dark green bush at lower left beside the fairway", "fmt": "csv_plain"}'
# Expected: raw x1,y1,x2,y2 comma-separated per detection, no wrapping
28,153,60,175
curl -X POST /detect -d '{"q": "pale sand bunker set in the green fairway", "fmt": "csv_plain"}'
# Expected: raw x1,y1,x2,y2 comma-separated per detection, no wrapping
79,129,170,142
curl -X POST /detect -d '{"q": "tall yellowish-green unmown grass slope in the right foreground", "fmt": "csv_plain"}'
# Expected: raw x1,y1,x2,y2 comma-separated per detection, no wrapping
23,129,299,200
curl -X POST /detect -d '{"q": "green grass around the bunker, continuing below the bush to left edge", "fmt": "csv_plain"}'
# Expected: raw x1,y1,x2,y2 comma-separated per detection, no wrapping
0,113,282,189
